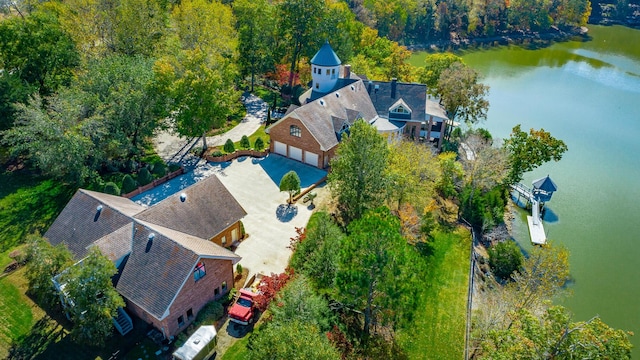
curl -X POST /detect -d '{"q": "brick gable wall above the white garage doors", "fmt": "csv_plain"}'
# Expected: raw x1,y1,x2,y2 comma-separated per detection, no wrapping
269,117,335,169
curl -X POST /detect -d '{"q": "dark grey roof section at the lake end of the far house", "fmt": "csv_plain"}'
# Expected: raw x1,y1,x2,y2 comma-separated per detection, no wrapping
367,81,427,122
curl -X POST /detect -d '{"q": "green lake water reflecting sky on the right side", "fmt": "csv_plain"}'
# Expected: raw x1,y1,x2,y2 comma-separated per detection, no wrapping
412,26,640,356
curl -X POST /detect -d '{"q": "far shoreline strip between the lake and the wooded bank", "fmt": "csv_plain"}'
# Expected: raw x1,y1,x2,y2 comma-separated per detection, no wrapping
407,26,589,52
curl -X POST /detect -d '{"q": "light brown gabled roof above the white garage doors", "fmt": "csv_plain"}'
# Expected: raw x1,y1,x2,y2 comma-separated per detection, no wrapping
271,80,376,151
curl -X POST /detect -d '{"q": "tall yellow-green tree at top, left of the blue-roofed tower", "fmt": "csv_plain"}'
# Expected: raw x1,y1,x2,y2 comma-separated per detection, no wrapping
160,0,239,149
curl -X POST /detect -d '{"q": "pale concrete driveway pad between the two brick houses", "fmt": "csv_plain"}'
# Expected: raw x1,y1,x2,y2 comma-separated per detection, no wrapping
132,154,327,275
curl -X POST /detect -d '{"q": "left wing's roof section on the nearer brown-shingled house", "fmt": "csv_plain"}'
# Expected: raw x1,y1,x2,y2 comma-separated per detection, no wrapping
44,189,144,260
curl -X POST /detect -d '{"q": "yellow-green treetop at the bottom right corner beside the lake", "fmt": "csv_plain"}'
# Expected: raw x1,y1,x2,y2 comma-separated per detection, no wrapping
481,306,632,359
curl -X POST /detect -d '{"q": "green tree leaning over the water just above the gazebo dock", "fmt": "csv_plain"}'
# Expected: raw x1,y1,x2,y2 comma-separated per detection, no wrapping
504,124,568,184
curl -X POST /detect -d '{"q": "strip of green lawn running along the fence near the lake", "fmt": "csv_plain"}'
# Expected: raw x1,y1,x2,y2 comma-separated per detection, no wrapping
398,228,471,359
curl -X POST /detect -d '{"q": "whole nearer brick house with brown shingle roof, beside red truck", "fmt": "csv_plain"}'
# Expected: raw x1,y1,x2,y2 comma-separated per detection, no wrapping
44,176,246,338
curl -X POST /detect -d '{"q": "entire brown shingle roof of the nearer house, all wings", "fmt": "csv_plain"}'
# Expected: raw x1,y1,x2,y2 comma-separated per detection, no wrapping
45,176,246,319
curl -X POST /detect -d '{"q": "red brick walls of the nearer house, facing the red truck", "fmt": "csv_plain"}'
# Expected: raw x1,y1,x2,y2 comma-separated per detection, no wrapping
125,259,233,338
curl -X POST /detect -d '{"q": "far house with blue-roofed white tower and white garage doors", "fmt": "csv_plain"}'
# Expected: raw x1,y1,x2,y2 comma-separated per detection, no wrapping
265,42,448,168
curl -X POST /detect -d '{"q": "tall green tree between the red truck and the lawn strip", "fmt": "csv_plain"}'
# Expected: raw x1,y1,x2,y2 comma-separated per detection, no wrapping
335,208,415,339
